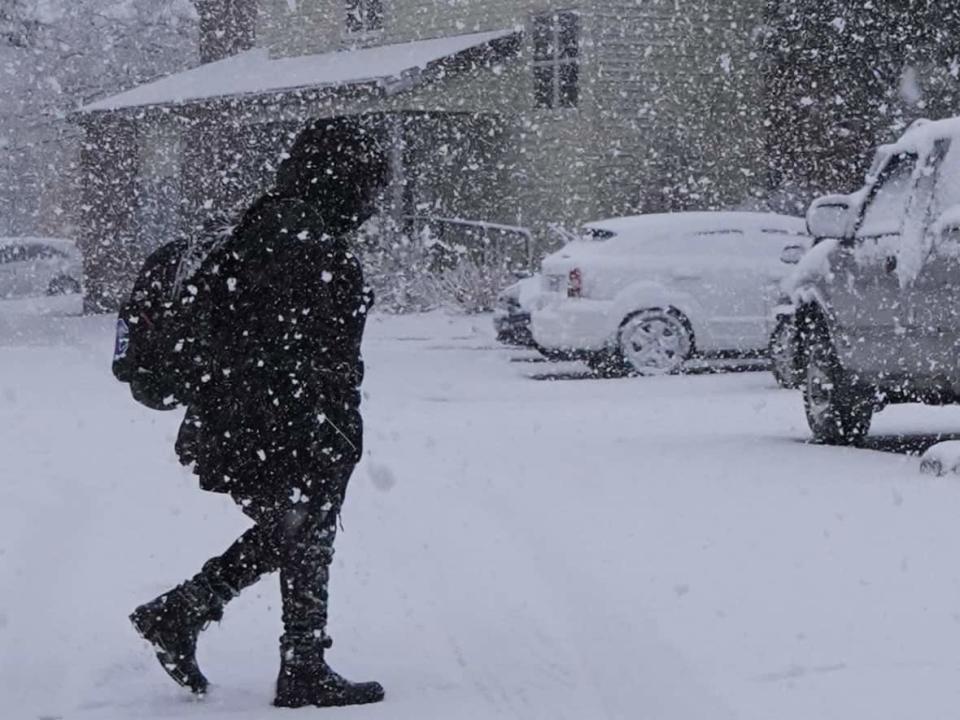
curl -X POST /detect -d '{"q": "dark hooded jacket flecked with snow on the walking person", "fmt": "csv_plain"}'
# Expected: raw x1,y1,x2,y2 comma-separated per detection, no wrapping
178,116,385,500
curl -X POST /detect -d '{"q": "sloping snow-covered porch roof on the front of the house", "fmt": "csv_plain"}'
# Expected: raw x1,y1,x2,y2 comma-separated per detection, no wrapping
80,29,519,113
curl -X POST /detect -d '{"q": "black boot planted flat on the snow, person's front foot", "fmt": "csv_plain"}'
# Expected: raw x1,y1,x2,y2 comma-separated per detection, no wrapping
273,638,384,708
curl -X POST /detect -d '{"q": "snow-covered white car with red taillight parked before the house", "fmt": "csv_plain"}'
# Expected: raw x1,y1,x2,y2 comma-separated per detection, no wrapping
532,212,810,375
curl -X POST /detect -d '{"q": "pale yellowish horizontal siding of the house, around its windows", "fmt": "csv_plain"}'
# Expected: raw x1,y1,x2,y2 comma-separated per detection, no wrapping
258,0,766,235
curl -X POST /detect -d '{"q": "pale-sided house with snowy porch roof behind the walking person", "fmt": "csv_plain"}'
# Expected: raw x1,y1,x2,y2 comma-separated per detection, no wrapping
76,0,767,311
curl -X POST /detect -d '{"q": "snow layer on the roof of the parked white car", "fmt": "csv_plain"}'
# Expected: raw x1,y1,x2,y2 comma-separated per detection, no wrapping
584,212,807,235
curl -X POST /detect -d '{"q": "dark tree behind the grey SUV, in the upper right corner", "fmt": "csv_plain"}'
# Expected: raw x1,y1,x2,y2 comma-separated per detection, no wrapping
766,0,960,202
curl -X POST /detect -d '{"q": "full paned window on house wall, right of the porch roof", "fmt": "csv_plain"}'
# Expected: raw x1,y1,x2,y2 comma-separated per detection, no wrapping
533,10,580,108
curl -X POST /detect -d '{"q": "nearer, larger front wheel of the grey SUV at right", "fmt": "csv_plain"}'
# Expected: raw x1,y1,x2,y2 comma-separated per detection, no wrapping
803,332,874,445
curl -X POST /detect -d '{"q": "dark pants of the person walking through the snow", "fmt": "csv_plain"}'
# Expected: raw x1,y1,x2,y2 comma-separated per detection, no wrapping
201,466,353,659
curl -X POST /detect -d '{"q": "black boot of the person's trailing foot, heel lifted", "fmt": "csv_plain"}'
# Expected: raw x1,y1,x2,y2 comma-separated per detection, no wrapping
130,573,235,695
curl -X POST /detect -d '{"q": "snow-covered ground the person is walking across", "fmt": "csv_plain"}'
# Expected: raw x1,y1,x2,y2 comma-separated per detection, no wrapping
0,314,960,720
